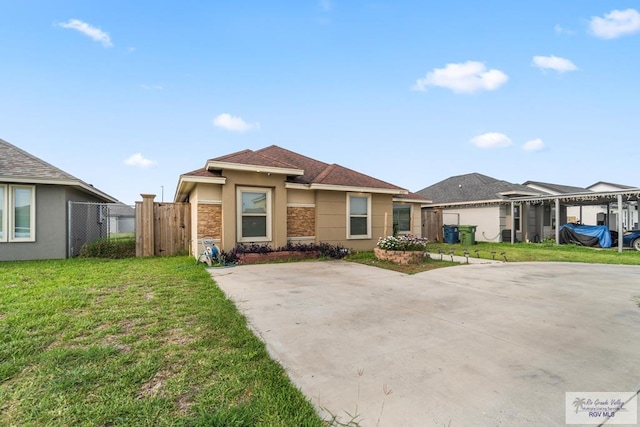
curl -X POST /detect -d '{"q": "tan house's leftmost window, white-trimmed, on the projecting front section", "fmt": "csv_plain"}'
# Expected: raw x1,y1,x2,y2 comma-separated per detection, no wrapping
237,187,271,242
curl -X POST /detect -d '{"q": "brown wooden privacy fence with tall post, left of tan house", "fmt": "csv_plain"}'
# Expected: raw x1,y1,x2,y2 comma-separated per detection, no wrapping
136,194,191,257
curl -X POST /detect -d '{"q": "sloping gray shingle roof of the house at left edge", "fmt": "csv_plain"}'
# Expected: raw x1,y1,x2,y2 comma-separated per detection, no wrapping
0,139,117,202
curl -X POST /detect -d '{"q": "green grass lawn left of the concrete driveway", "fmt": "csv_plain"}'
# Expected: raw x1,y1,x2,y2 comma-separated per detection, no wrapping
0,257,324,426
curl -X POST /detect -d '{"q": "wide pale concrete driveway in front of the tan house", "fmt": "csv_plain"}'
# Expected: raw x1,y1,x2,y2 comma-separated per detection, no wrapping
211,261,640,427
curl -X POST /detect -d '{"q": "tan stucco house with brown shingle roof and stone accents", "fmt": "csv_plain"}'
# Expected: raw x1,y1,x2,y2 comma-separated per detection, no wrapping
174,145,429,255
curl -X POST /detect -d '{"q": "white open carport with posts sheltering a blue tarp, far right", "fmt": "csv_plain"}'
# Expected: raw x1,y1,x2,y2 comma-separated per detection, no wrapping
510,188,640,252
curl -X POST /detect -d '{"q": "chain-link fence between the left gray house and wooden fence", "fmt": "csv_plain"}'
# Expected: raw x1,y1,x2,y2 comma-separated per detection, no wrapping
68,202,136,258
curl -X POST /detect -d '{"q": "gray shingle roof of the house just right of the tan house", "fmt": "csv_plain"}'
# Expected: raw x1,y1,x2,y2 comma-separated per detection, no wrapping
416,173,540,204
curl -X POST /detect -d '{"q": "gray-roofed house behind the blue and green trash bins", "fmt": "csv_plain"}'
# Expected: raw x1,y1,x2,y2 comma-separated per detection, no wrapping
416,173,541,242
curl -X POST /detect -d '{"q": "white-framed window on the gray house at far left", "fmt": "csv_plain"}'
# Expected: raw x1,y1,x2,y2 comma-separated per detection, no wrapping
0,185,36,242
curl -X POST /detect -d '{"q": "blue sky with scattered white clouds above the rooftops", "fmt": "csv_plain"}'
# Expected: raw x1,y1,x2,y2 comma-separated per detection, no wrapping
0,0,640,204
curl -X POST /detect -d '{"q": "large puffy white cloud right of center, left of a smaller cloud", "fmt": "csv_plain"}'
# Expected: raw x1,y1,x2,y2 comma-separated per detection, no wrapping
412,61,509,93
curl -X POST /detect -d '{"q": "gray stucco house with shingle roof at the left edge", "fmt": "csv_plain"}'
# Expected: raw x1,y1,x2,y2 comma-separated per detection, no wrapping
0,139,117,261
